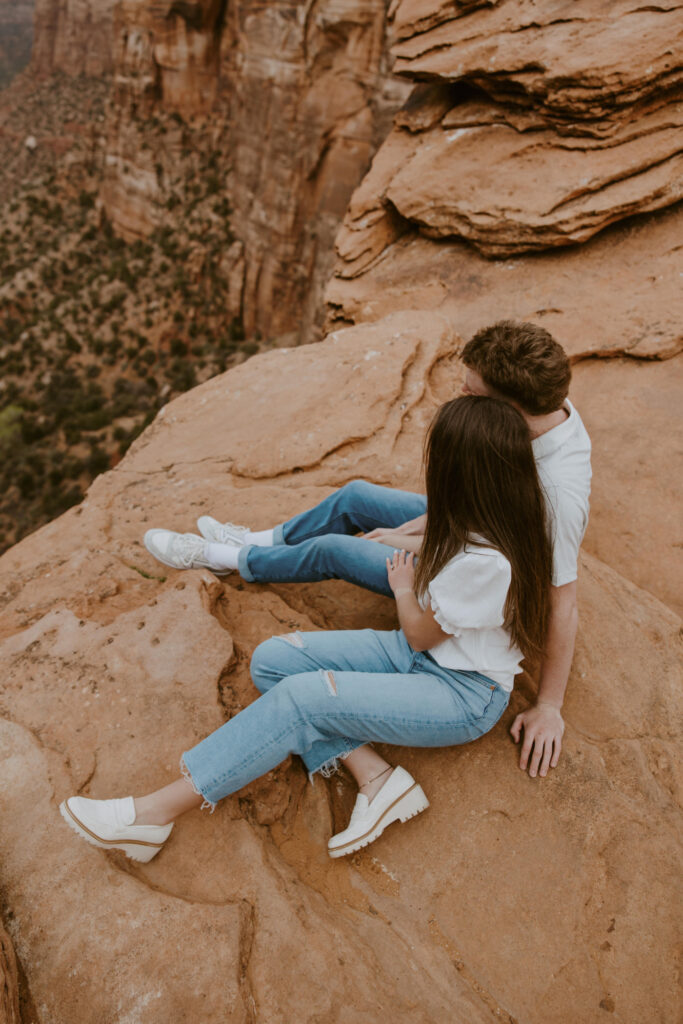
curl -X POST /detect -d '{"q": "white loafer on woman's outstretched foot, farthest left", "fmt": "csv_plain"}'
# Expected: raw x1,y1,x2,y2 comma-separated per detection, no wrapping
59,797,173,863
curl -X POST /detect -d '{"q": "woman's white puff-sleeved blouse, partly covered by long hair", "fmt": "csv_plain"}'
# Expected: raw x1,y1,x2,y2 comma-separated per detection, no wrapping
422,543,523,691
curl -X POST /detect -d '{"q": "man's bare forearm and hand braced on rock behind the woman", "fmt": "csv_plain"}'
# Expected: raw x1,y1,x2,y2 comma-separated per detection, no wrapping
510,581,579,778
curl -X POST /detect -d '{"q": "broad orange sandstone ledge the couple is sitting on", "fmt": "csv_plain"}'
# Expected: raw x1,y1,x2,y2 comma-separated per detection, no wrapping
0,310,681,1024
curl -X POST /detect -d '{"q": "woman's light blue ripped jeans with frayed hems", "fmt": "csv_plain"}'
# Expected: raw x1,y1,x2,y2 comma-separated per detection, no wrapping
182,630,509,805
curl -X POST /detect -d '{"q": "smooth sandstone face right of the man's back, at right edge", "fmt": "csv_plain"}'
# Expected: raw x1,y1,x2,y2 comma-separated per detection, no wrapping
571,355,683,615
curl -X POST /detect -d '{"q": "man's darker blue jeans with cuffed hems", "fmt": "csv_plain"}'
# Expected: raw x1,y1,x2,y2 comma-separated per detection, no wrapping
238,480,427,596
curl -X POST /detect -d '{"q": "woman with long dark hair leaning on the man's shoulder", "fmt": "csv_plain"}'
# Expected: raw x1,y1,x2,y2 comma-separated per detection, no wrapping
59,396,551,861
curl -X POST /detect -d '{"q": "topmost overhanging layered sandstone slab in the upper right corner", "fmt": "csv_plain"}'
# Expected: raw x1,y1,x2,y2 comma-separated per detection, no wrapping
394,0,683,122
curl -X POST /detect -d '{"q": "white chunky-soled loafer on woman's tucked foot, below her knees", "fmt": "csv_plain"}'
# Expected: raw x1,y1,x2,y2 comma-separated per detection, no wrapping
328,768,429,857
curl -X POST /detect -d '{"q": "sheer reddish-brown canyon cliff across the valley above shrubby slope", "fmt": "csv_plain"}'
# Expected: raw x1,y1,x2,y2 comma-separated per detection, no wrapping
102,0,410,340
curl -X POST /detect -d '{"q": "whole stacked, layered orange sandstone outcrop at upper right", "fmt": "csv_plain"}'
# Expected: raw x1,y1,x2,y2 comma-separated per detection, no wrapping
336,0,683,268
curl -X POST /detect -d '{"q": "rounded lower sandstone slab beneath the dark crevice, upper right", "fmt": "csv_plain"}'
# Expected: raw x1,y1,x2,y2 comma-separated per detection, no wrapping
382,105,683,256
